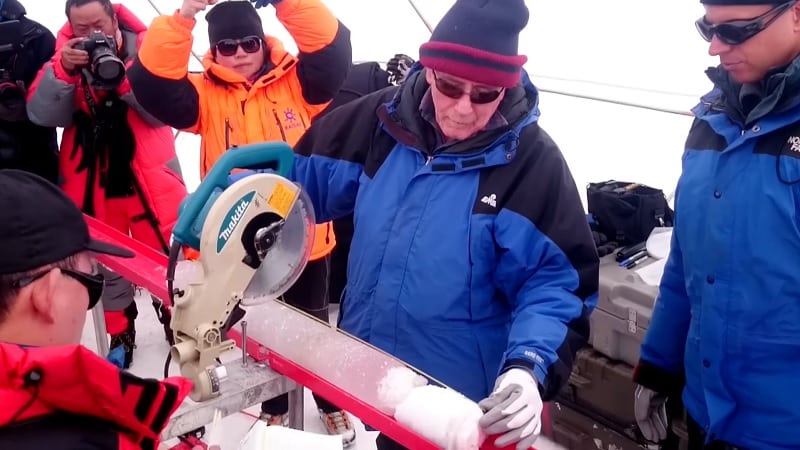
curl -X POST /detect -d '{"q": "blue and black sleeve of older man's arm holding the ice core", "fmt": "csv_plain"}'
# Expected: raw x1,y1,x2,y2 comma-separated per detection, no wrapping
494,124,600,401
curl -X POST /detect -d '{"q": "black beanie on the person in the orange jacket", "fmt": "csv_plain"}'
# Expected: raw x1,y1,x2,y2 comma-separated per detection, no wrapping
206,0,264,47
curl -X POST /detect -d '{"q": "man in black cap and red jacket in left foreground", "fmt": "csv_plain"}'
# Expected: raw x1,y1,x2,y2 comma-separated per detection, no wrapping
0,169,192,450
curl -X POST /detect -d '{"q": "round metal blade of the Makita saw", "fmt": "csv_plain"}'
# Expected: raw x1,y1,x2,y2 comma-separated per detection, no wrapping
242,183,316,306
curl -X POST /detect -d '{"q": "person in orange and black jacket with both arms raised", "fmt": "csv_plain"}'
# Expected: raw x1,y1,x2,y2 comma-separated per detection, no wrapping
128,0,355,446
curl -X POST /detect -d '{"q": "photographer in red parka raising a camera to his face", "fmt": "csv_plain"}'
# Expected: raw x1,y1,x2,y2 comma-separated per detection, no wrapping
28,0,187,368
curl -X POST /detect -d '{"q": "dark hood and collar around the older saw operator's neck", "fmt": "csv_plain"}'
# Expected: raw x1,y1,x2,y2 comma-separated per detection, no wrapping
379,62,540,153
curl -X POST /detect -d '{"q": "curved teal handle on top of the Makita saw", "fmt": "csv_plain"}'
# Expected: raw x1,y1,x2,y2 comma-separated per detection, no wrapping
172,141,294,250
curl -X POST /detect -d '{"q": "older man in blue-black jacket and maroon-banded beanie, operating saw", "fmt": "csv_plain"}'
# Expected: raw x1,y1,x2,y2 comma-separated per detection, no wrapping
293,0,599,449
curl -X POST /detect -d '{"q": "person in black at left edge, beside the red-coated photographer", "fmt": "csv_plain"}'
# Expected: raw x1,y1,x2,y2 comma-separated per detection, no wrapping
0,0,58,183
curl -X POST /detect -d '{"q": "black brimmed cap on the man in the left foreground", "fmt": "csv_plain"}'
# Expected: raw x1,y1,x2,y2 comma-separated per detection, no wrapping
0,169,134,275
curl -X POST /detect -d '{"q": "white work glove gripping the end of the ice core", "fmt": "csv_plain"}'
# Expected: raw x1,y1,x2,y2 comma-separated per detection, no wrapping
478,368,544,450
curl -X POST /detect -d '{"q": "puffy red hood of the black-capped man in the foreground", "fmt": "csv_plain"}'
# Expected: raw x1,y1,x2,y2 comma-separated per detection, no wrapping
0,344,192,442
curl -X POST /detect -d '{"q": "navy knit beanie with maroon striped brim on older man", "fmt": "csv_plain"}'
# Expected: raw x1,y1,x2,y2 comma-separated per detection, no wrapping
419,0,529,88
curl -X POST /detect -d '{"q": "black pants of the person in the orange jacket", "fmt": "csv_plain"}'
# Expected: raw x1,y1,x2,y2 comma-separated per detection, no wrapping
261,256,341,415
